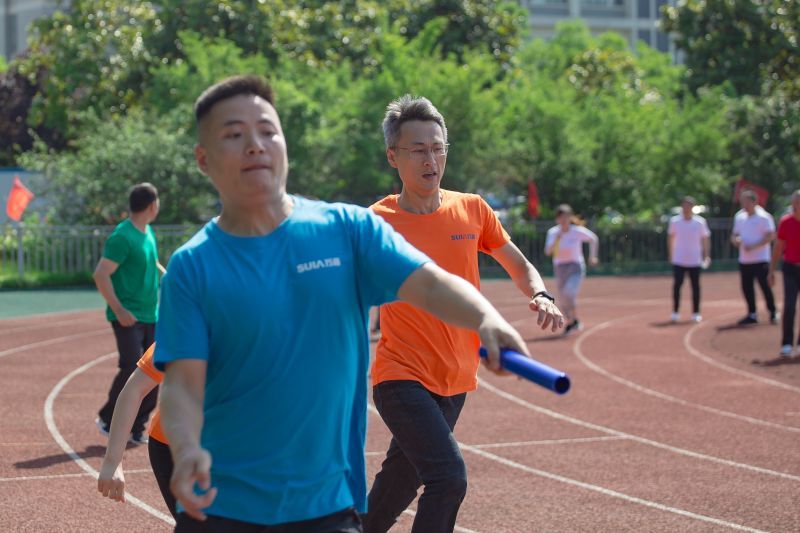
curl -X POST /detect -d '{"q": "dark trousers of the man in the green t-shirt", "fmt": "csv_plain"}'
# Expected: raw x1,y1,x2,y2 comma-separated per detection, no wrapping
98,320,158,433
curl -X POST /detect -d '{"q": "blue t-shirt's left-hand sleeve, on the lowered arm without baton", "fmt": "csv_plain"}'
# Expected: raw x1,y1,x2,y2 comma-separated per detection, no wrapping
154,254,209,372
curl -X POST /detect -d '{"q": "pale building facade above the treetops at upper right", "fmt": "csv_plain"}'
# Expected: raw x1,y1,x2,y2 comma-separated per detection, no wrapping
522,0,680,61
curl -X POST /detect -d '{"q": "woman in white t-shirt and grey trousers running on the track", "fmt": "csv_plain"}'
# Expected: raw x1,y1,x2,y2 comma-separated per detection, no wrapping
544,204,599,335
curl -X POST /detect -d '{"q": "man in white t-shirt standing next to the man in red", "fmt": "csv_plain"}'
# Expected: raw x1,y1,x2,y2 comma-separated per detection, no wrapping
731,189,779,326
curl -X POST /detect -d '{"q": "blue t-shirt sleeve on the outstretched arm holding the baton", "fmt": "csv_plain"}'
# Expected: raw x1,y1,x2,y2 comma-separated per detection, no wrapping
351,208,430,305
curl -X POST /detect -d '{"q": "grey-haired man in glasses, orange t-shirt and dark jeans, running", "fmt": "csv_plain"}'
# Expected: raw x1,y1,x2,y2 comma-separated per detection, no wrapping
363,95,564,533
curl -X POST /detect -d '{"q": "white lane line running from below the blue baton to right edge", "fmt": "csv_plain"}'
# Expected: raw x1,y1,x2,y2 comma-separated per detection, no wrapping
478,377,800,481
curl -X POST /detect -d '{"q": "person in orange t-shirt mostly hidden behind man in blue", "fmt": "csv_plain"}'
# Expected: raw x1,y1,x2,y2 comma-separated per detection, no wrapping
97,343,178,518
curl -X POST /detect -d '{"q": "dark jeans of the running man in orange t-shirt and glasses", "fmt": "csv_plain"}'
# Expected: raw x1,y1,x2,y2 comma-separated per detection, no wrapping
363,381,467,533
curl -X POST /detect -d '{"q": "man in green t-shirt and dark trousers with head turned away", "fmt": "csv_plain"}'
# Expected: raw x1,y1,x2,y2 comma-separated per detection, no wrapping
94,183,164,444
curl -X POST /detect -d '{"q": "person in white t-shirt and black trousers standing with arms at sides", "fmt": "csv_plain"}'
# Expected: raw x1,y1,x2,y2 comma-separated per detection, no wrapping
667,196,711,322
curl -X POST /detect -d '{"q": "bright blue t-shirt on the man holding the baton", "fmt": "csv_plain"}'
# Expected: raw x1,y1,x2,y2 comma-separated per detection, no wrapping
155,196,429,525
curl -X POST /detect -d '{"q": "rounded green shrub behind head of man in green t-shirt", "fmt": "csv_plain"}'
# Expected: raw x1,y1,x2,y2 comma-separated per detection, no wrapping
20,111,216,224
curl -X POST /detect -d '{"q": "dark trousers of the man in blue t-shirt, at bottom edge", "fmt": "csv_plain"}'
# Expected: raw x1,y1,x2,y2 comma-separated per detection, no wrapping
175,508,362,533
